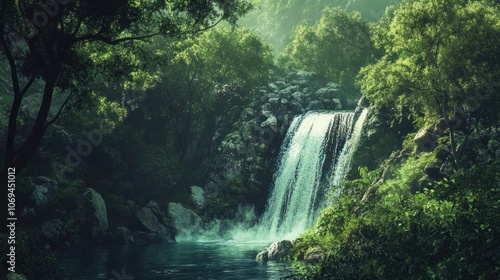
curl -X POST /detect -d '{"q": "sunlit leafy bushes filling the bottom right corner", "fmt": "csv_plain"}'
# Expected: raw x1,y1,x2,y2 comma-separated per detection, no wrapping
290,155,500,279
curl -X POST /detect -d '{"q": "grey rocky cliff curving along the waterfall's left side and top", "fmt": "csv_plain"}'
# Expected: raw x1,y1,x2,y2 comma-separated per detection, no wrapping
203,72,345,218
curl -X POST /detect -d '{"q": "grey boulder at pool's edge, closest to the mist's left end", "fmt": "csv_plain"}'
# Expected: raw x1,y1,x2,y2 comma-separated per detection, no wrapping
168,202,201,234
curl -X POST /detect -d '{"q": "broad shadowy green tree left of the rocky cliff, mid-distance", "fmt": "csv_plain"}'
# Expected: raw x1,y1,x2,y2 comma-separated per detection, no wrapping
124,27,273,166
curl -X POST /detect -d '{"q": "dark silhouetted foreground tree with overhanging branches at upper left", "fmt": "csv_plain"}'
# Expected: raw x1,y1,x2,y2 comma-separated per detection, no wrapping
0,0,251,233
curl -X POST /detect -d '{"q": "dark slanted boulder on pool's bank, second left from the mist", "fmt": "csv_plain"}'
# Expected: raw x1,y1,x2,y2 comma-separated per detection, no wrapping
135,201,175,242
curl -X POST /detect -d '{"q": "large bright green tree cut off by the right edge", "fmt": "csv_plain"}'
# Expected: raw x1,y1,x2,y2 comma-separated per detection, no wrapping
361,0,500,167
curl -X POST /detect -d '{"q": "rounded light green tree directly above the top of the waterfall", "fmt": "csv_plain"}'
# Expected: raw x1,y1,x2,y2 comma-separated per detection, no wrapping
280,8,376,105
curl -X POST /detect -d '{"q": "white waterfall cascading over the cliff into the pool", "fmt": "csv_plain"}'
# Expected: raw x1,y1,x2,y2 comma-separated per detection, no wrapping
260,110,367,240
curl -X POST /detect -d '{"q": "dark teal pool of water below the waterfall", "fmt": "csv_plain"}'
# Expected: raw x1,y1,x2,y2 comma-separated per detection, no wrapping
67,241,291,280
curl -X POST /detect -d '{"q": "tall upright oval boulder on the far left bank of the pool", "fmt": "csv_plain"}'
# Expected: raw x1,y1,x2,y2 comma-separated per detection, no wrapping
80,188,109,241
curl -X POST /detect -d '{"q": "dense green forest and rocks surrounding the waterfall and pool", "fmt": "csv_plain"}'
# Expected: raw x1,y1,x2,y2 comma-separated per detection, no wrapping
0,0,500,280
